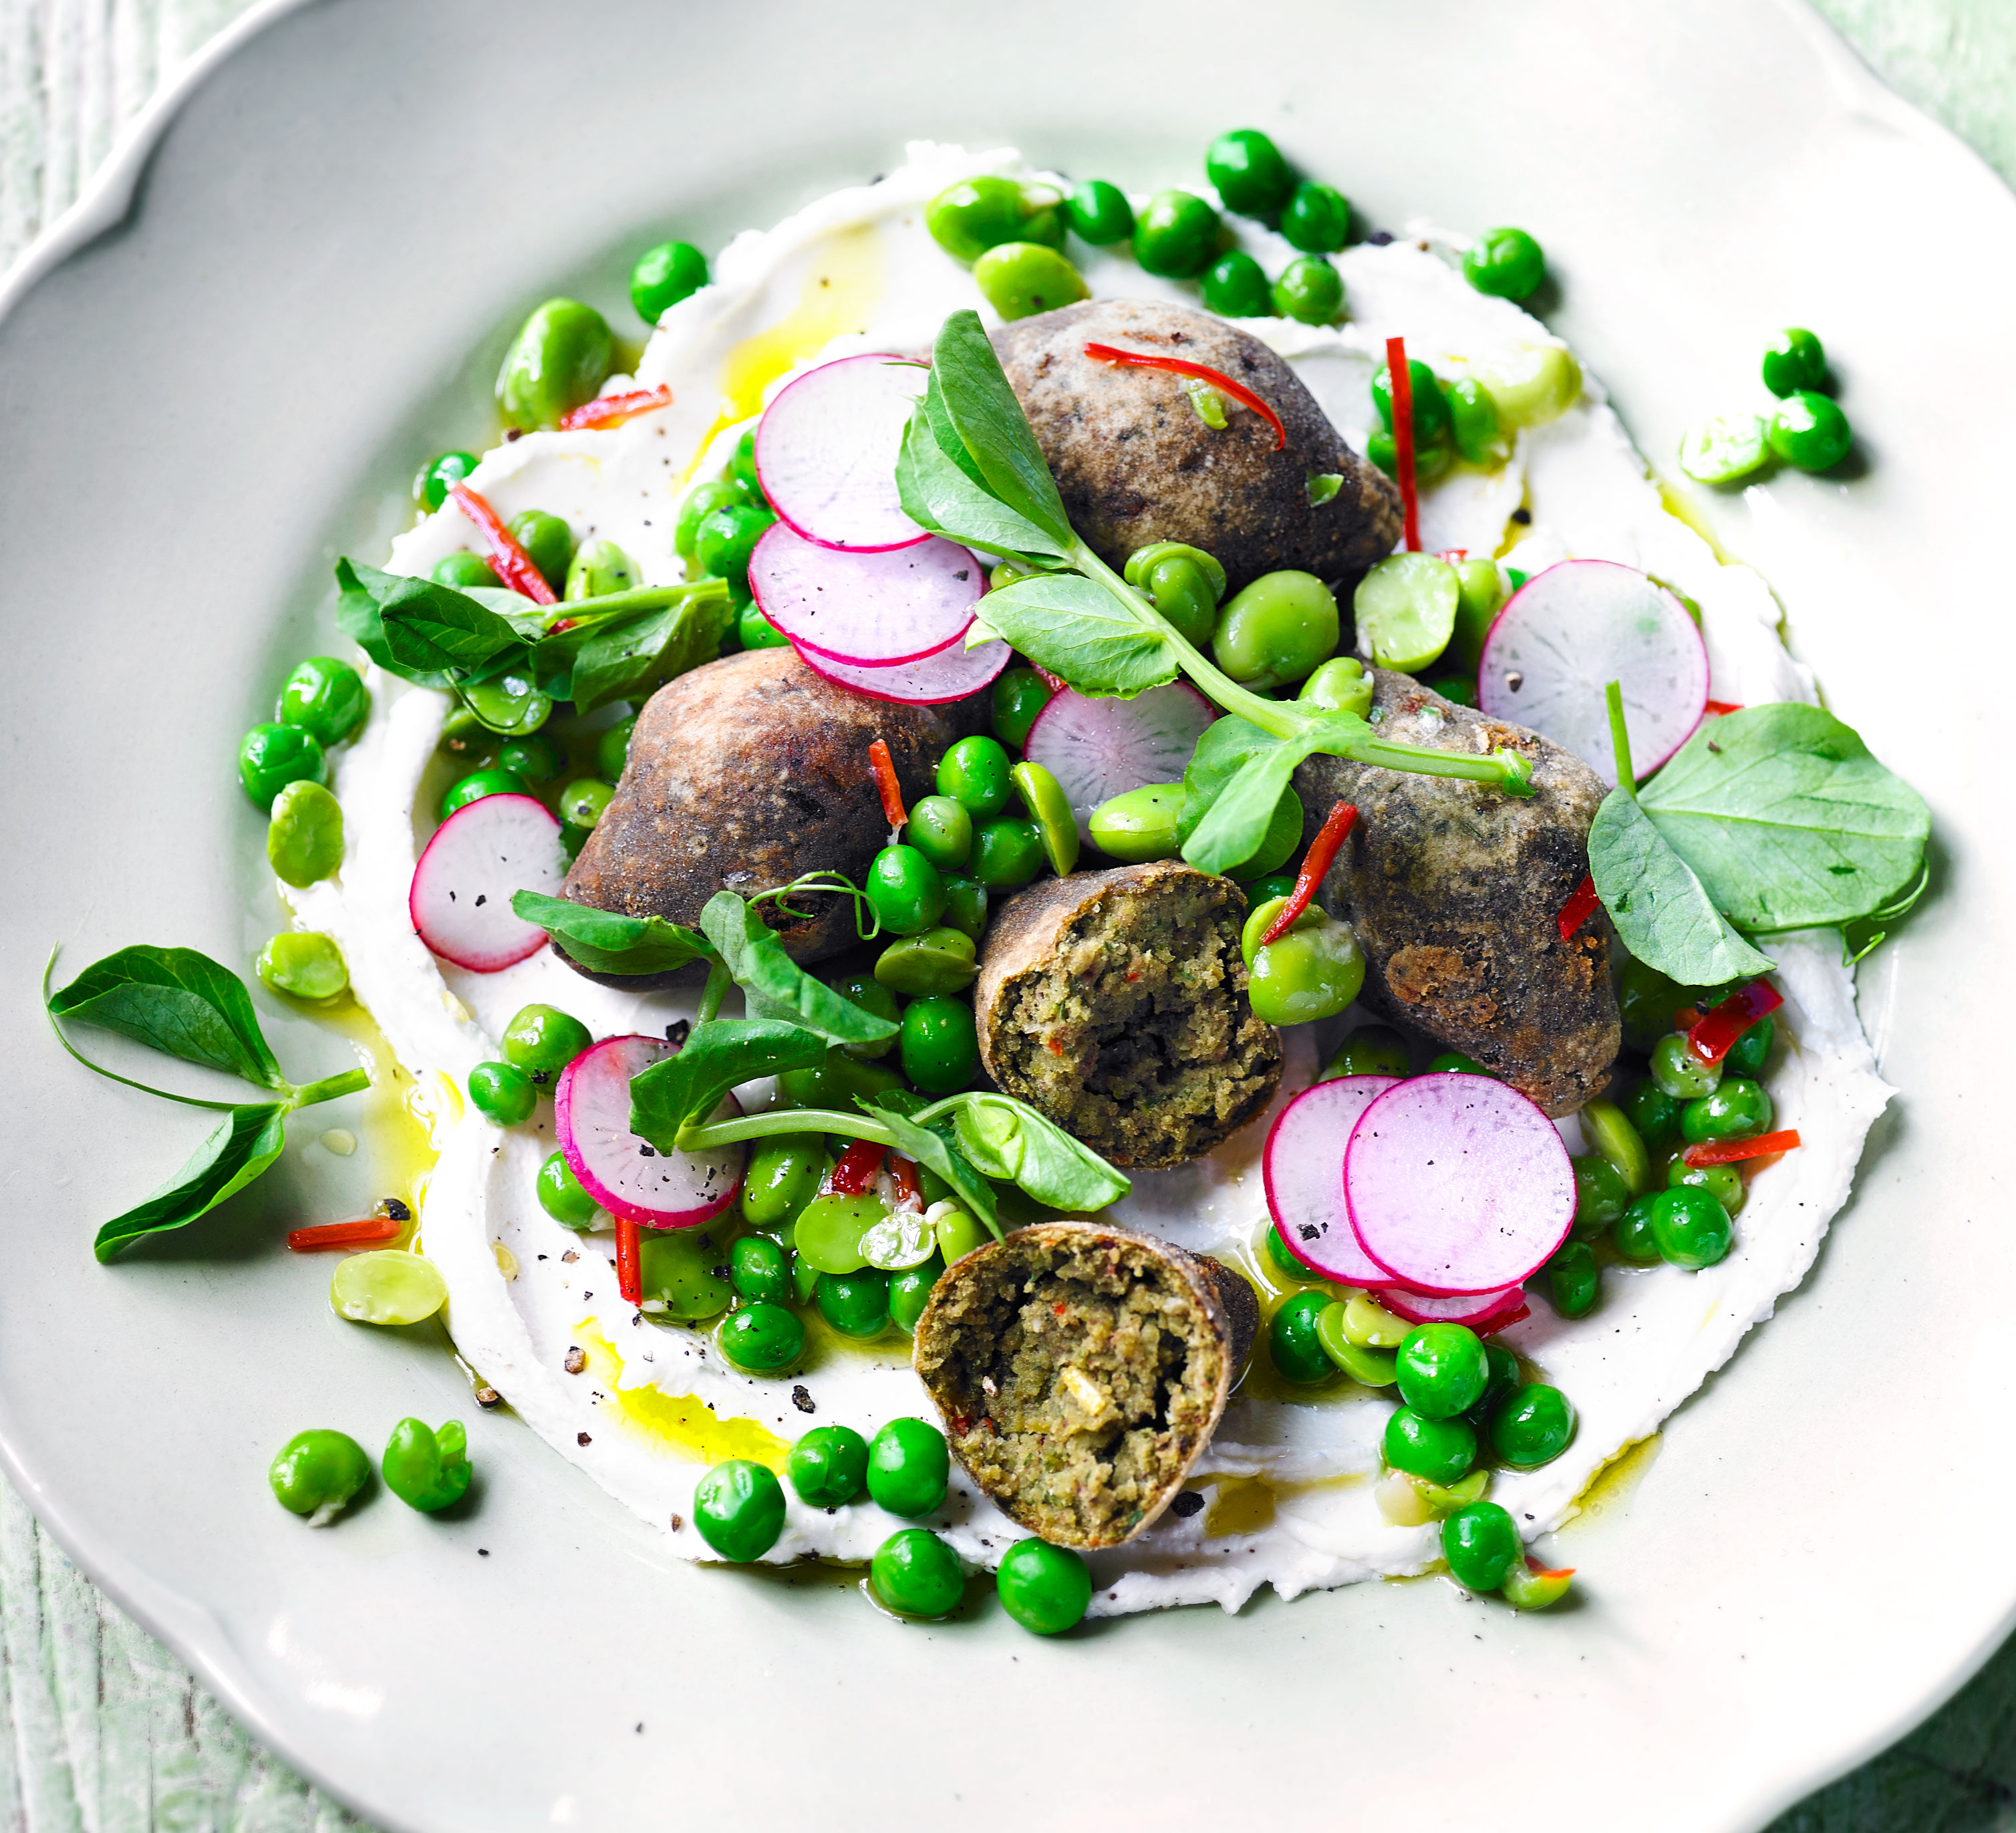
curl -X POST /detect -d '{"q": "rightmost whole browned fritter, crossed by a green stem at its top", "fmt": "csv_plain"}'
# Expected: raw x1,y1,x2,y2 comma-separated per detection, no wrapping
1294,668,1621,1115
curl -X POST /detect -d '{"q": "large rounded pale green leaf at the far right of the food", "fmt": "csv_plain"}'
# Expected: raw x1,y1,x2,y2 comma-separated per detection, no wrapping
1639,700,1931,932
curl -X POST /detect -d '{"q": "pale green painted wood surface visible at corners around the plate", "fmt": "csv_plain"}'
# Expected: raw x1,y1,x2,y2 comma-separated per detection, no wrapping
0,0,2016,1833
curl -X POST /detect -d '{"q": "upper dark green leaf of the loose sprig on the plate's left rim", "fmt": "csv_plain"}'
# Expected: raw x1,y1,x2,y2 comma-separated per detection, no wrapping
48,946,292,1095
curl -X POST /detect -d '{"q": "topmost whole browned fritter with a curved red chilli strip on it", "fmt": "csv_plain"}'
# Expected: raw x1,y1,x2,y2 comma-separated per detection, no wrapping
994,299,1401,591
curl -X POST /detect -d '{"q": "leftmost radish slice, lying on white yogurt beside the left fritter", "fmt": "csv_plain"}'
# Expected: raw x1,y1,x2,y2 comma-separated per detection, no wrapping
405,795,567,974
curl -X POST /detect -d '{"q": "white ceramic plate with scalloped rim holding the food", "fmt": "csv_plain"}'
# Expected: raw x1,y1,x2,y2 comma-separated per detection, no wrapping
0,0,2016,1833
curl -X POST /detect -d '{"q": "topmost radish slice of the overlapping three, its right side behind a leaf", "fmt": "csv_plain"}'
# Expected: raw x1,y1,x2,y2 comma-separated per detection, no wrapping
756,353,927,553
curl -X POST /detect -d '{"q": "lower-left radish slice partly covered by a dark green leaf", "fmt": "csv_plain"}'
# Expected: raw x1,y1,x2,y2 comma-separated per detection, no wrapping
553,1036,744,1228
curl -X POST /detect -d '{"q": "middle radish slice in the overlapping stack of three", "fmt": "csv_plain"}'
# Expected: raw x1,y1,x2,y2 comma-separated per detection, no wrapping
750,523,988,668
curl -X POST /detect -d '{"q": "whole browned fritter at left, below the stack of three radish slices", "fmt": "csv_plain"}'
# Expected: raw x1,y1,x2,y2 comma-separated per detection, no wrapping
561,650,984,990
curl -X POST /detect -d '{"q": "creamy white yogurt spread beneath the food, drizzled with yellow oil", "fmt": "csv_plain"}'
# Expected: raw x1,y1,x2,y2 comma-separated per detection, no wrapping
286,143,1889,1613
